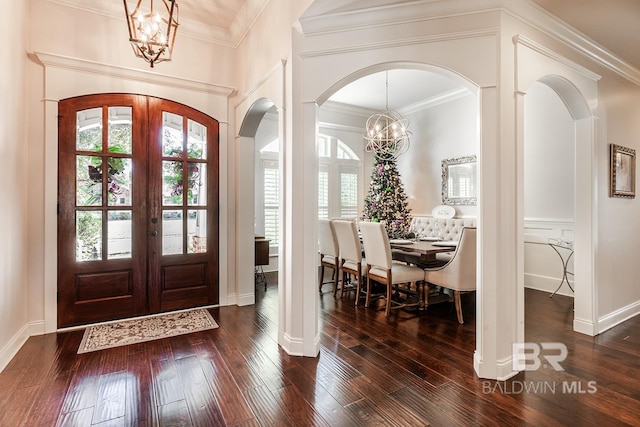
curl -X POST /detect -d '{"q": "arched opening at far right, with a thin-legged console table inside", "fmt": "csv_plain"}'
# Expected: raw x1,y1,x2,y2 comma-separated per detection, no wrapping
521,75,597,335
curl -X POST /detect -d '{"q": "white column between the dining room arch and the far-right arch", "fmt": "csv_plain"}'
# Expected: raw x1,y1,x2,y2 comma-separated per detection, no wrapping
474,87,517,380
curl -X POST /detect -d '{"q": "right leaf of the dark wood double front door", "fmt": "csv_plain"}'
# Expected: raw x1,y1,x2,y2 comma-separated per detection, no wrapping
149,99,218,312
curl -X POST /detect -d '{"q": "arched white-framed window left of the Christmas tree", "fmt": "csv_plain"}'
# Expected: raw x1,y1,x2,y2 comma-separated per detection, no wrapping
318,134,361,219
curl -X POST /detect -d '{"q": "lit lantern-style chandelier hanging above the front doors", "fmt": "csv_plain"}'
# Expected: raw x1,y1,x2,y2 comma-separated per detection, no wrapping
123,0,178,68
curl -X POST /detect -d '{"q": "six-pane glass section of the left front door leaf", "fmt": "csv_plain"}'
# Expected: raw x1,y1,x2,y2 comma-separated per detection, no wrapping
75,106,133,261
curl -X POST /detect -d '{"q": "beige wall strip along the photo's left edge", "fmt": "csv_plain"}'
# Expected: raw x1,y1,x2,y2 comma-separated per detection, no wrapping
0,2,32,371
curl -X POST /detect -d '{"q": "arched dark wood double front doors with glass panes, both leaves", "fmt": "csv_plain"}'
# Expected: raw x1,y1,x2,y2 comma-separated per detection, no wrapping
58,94,218,327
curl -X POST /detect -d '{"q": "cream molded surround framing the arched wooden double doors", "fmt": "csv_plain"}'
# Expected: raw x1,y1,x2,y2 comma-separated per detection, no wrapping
35,52,236,336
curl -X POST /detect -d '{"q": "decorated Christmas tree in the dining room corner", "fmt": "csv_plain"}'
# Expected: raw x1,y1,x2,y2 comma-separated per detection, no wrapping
362,159,411,239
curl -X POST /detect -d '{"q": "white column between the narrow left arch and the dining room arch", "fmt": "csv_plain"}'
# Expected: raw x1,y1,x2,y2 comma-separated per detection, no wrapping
279,69,320,357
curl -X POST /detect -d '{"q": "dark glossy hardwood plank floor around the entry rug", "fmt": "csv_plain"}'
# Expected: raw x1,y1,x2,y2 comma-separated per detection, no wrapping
0,277,640,427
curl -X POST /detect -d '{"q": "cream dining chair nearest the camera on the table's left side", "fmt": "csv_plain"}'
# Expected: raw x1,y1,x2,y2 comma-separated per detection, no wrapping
360,222,424,317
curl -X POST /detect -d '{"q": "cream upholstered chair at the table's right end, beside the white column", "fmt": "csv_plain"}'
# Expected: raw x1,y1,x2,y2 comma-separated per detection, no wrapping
424,227,476,324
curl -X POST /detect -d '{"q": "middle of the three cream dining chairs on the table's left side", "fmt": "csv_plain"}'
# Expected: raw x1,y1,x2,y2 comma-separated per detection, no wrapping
331,219,367,305
